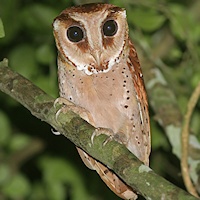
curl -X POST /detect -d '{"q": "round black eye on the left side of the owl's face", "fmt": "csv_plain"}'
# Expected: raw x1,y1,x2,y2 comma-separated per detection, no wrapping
67,26,84,42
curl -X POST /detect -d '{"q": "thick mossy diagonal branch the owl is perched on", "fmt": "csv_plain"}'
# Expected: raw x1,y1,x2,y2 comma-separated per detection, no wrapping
0,60,197,200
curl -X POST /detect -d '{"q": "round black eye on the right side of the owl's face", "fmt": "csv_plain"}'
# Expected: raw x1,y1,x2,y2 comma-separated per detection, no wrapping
103,20,118,36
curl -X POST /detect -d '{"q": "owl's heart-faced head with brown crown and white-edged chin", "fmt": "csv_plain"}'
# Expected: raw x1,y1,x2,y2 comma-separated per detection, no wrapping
53,4,128,75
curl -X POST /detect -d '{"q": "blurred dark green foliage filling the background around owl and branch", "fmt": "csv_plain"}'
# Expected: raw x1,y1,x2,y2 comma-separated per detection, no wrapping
0,0,200,200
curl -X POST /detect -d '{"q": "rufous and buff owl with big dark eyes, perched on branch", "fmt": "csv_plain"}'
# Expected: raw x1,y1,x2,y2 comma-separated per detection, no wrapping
53,3,151,199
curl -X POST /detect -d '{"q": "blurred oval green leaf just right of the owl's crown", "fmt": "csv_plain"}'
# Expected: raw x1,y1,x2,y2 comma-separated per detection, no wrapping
127,8,165,31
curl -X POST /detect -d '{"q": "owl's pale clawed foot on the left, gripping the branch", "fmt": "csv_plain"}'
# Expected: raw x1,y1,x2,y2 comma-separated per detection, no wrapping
54,97,94,126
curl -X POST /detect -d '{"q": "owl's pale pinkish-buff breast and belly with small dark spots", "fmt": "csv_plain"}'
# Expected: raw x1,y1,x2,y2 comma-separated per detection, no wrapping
59,59,149,160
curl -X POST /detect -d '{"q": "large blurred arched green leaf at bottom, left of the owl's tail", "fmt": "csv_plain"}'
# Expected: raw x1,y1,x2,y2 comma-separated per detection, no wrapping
39,157,90,200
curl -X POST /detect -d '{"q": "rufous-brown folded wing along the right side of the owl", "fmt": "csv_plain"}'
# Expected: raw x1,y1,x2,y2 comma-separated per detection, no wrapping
127,40,151,165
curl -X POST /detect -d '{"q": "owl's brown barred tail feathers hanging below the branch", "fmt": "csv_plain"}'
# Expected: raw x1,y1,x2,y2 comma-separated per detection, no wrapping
77,147,137,200
